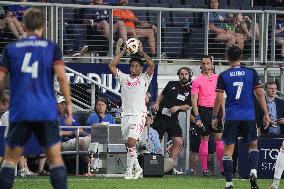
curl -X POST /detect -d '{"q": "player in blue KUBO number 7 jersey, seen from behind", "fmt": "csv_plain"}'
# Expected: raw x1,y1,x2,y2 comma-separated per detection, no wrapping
212,45,270,189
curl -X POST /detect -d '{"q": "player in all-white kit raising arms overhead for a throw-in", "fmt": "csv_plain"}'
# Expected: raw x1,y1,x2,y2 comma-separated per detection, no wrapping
109,44,155,179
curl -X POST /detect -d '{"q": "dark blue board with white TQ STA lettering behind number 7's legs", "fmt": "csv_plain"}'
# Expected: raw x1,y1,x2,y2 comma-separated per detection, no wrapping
238,138,284,179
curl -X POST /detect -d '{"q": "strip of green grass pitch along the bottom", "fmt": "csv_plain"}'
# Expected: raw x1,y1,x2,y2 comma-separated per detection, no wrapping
13,175,272,189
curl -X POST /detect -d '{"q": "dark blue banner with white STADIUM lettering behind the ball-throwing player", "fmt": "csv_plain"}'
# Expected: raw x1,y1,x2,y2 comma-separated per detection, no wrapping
66,63,158,101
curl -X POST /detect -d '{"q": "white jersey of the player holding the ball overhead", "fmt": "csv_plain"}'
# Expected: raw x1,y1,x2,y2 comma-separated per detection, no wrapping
116,69,152,115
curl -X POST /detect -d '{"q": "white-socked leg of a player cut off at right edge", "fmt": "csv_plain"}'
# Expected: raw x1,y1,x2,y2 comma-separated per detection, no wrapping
268,141,284,189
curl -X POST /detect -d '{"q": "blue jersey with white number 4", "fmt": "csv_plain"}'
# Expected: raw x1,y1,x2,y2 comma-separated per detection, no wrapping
0,36,64,123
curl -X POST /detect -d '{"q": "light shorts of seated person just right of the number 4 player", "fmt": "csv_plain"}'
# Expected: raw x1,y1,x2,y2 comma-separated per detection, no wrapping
61,136,91,151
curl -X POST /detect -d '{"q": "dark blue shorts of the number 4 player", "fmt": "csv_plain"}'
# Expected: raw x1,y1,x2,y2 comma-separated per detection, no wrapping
5,120,61,149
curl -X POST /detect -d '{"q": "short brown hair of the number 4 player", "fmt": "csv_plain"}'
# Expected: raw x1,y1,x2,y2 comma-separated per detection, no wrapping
23,8,45,31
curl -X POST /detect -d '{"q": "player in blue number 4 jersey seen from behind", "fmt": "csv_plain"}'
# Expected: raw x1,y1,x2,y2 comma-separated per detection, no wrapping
0,8,72,189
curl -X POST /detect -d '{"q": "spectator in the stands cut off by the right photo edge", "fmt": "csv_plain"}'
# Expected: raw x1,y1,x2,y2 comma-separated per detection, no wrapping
275,15,284,59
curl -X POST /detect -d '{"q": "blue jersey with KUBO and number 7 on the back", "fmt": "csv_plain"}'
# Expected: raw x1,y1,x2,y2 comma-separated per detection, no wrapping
216,66,262,120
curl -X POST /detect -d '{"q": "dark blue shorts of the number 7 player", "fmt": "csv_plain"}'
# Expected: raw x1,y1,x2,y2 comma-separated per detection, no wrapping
223,121,257,144
